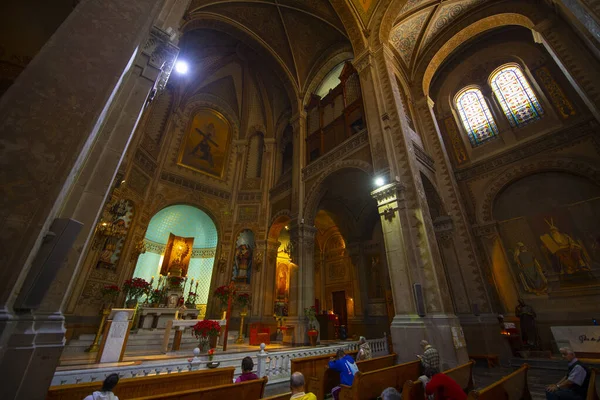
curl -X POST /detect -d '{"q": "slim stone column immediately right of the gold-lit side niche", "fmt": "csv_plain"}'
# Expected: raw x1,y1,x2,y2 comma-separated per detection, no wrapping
286,221,317,344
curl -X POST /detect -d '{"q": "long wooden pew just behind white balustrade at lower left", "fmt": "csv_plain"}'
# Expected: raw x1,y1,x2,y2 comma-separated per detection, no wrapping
46,367,235,400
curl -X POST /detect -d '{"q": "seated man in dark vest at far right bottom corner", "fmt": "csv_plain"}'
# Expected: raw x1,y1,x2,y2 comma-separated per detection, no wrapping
546,347,590,400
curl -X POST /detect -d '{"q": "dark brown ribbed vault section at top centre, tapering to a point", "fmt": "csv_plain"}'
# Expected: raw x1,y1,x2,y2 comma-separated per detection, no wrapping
187,0,351,92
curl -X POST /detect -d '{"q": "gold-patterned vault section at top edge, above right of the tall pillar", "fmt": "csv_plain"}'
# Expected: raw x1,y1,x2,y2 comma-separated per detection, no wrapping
390,0,489,70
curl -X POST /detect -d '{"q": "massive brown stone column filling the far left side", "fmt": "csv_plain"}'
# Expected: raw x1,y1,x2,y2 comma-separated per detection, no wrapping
0,0,168,399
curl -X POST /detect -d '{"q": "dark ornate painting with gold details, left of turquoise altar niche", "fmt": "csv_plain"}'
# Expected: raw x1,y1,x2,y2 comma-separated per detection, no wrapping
93,199,133,271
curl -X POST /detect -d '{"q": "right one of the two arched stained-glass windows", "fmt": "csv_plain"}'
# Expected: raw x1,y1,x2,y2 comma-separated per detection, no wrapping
490,65,544,126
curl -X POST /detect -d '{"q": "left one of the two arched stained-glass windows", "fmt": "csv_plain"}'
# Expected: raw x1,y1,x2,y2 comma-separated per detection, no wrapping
456,88,498,147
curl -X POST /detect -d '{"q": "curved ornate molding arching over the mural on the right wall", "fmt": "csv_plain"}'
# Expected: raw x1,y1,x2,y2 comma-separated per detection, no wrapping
477,157,600,225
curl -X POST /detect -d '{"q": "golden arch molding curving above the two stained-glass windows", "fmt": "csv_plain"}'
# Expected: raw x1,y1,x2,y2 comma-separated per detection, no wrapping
414,7,546,95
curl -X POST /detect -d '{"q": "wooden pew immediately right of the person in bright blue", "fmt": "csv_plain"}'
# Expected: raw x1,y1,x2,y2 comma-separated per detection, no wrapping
340,360,421,400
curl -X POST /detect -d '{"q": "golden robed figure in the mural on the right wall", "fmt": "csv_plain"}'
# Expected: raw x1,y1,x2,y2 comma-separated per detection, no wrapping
540,219,590,275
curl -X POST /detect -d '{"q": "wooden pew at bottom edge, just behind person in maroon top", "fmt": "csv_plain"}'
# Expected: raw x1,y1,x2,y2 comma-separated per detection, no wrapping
134,376,269,400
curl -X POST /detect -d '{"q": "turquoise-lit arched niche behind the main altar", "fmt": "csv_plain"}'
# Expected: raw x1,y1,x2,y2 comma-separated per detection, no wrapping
133,204,218,304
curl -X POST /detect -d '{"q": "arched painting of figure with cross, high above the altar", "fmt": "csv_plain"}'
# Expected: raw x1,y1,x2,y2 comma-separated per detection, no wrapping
177,109,231,178
